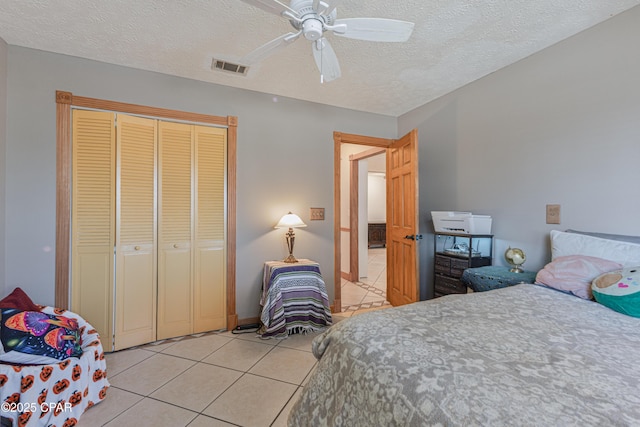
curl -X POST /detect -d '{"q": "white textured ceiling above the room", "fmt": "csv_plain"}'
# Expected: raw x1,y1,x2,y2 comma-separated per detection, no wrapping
0,0,640,116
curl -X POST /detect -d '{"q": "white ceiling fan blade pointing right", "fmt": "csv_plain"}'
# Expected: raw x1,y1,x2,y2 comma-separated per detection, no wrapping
328,18,414,42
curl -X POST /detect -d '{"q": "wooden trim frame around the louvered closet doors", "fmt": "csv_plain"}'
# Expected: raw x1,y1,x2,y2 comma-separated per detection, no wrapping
55,91,238,330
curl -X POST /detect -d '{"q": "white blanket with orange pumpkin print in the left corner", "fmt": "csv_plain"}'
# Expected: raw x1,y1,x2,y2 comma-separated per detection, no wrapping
0,298,109,427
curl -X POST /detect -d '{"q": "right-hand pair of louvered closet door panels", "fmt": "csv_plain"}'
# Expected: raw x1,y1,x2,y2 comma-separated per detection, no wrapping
158,122,226,339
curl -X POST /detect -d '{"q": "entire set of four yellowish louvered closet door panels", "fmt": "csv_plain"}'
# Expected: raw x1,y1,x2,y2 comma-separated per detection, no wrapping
71,110,226,350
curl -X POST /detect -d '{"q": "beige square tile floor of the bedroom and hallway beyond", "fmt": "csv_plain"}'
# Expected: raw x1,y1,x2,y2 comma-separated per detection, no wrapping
78,248,388,427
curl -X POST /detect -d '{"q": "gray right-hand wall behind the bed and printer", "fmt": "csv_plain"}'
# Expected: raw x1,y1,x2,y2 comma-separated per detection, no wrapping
398,7,640,298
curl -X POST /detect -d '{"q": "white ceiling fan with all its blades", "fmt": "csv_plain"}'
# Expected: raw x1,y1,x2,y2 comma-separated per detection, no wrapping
240,0,414,82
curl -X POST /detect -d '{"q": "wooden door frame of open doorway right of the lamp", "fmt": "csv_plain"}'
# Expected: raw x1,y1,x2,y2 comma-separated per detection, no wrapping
332,132,395,313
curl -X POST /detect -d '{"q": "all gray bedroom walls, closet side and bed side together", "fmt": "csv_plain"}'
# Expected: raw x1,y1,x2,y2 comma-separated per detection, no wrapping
0,2,640,310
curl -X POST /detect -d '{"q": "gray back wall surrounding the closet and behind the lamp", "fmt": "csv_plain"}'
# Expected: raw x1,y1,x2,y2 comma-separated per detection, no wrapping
5,46,396,319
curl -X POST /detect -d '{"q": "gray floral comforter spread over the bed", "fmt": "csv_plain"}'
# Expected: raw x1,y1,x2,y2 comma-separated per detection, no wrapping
289,285,640,427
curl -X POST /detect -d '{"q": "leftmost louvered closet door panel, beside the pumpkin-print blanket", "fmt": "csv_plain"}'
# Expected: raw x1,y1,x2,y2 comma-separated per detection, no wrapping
71,110,115,351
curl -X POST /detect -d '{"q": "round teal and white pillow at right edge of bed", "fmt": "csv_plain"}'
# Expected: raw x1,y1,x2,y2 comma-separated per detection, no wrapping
591,266,640,317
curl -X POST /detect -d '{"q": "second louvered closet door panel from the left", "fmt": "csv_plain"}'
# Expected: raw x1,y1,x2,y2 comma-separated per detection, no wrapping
115,115,157,350
